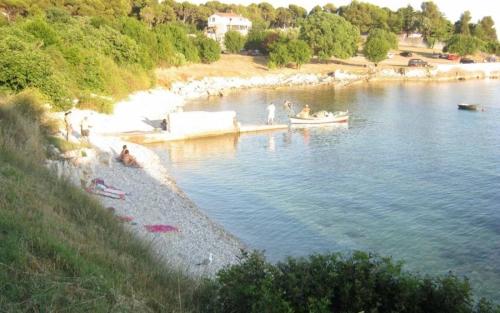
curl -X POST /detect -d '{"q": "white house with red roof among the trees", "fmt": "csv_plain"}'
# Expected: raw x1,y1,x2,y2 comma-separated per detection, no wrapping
207,12,252,44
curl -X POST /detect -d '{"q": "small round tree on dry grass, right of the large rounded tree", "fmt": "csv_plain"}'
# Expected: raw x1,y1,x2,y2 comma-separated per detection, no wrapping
363,29,398,63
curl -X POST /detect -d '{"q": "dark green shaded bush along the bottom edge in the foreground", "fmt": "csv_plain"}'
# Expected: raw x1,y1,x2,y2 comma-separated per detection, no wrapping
207,252,498,313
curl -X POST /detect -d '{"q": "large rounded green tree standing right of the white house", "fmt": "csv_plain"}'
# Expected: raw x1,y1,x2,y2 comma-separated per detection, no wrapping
300,12,359,59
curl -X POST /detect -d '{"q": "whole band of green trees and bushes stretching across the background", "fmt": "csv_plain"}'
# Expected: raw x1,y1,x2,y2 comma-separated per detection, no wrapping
0,0,500,108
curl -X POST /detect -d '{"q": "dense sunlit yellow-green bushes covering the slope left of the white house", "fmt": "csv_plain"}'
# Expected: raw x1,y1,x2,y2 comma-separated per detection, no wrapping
0,6,211,111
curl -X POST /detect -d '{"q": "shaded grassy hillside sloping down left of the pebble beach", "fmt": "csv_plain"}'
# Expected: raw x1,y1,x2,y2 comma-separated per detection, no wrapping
0,92,205,312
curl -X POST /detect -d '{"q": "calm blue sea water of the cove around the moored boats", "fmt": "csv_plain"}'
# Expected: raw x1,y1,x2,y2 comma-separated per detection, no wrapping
156,81,500,301
